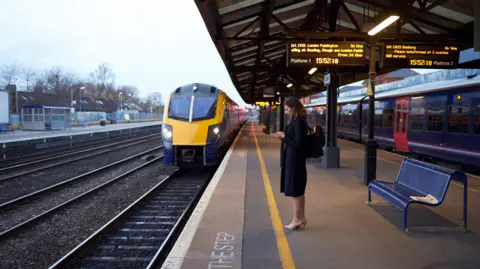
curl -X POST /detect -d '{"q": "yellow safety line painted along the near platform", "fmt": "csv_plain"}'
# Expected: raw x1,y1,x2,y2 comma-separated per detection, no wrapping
252,122,295,269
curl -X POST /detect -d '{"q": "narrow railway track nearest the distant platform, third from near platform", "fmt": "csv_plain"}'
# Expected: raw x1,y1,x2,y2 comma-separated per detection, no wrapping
0,134,161,182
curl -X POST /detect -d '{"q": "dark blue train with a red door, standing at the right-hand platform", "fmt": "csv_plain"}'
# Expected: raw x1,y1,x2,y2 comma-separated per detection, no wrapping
306,72,480,170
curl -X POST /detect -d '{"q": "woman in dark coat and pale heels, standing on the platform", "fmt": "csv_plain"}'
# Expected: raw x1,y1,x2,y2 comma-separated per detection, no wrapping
274,97,308,230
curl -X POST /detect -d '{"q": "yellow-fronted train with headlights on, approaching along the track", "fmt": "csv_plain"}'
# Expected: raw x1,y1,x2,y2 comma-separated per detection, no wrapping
162,83,246,167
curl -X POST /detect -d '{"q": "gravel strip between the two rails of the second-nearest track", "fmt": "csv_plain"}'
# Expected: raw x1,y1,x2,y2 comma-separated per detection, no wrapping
0,150,161,231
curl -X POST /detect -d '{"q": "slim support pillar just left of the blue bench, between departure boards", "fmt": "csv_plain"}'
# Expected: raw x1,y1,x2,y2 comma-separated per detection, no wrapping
363,38,377,186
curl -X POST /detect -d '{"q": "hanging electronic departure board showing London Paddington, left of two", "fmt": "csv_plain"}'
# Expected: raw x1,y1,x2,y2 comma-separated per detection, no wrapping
287,41,367,67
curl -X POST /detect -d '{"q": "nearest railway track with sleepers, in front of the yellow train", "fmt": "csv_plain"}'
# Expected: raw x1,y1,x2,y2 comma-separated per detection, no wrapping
50,169,213,269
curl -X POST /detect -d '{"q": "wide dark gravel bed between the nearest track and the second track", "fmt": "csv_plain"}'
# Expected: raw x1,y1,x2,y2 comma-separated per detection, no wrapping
0,161,176,269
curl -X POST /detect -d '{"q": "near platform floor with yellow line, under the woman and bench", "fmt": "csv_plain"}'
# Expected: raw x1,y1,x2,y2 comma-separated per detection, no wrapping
162,122,480,269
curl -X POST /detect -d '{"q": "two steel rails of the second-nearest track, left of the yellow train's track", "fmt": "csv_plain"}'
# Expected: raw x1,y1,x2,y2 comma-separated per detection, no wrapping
0,147,163,240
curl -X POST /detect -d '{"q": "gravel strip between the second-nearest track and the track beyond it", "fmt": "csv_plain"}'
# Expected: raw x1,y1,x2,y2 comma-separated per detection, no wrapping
0,139,161,203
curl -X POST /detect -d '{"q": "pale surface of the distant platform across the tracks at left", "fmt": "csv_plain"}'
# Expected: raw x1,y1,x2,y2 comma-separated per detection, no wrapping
0,121,162,143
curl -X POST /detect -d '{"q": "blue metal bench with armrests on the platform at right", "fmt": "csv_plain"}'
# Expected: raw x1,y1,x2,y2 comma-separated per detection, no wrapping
368,159,468,232
